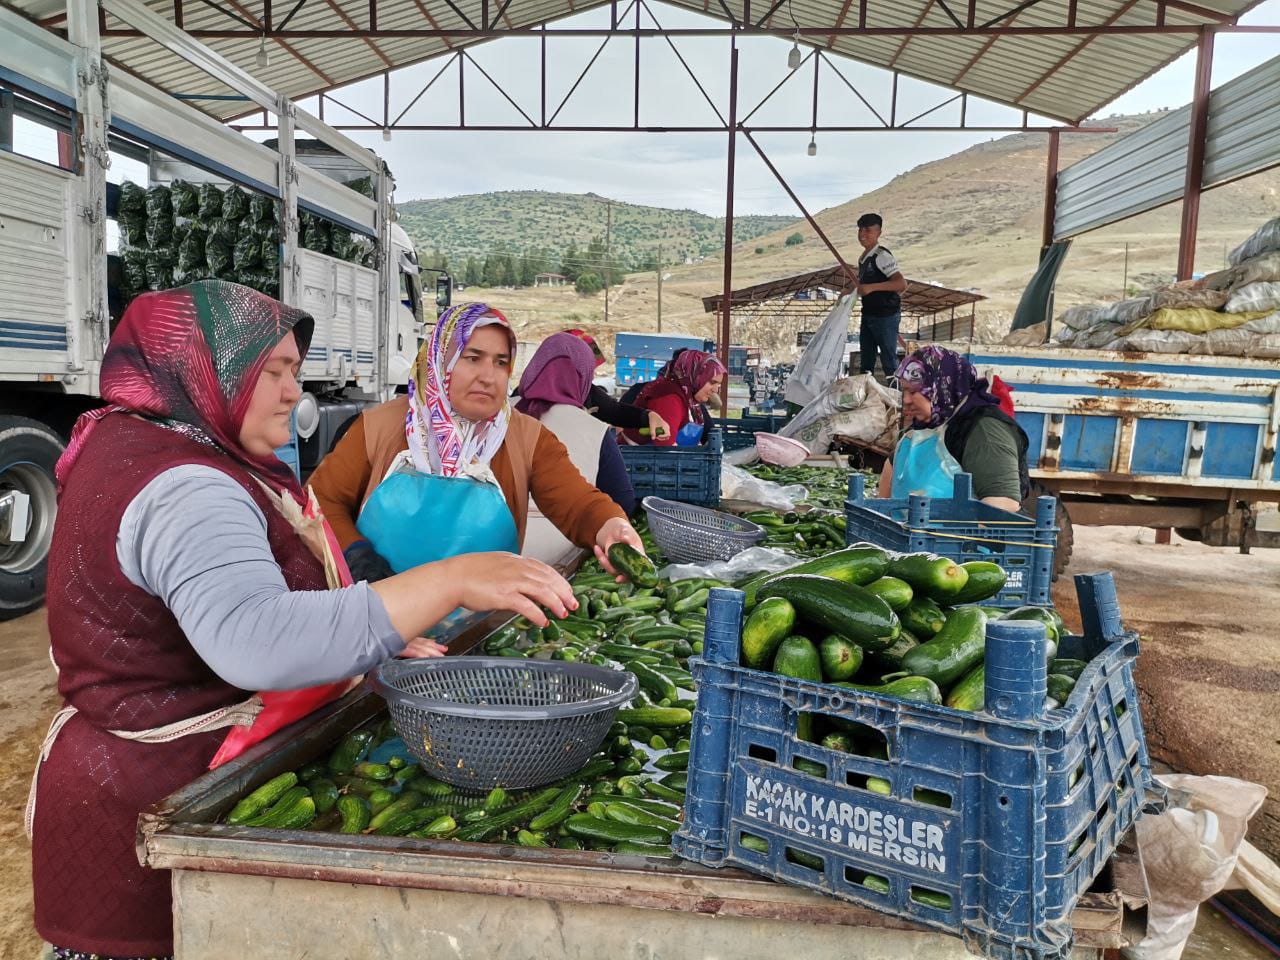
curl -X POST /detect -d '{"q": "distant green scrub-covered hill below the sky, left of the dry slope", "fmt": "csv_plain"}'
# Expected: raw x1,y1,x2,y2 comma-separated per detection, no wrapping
397,191,796,265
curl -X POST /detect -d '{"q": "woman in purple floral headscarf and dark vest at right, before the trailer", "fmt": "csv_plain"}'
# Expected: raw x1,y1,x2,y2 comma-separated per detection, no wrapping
879,344,1029,511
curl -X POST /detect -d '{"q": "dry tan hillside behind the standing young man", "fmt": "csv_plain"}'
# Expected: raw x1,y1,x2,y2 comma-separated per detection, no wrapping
417,114,1280,360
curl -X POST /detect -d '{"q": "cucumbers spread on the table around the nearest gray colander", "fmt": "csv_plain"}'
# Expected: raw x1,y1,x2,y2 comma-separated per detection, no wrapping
218,542,701,856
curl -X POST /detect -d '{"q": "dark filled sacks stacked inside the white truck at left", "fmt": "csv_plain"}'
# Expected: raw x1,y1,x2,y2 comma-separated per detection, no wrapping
116,178,374,297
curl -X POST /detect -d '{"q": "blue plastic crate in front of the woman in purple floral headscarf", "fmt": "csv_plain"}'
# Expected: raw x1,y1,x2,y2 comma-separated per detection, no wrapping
845,474,1057,608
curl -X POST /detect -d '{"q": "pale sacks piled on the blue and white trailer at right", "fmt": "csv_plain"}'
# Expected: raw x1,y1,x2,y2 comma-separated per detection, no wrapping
1056,218,1280,358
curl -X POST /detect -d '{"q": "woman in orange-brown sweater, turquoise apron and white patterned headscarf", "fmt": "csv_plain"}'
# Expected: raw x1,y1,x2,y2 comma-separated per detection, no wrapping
311,303,643,583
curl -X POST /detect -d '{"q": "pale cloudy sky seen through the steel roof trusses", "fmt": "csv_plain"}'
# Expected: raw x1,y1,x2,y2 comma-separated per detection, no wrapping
262,0,1280,216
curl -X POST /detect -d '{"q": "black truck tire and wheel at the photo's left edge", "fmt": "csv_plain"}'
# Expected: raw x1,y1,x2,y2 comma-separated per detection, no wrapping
0,416,63,620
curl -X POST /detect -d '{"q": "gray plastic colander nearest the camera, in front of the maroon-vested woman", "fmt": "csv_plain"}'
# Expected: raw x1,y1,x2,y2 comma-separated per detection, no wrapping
374,657,636,791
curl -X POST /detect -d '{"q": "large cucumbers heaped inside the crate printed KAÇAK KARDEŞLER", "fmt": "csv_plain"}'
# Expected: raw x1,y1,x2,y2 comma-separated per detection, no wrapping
741,544,1085,716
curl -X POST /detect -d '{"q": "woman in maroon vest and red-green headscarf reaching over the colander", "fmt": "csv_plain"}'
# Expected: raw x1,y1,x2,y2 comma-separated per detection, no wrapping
27,280,573,960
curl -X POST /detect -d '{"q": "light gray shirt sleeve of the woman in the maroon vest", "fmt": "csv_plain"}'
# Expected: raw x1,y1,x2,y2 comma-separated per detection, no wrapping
115,463,404,690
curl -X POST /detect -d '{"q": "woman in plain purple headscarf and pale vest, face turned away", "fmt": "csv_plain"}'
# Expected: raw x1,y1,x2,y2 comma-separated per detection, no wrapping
516,333,635,563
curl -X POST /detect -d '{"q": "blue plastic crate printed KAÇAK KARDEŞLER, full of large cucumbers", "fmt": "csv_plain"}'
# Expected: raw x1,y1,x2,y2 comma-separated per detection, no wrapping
672,573,1153,960
